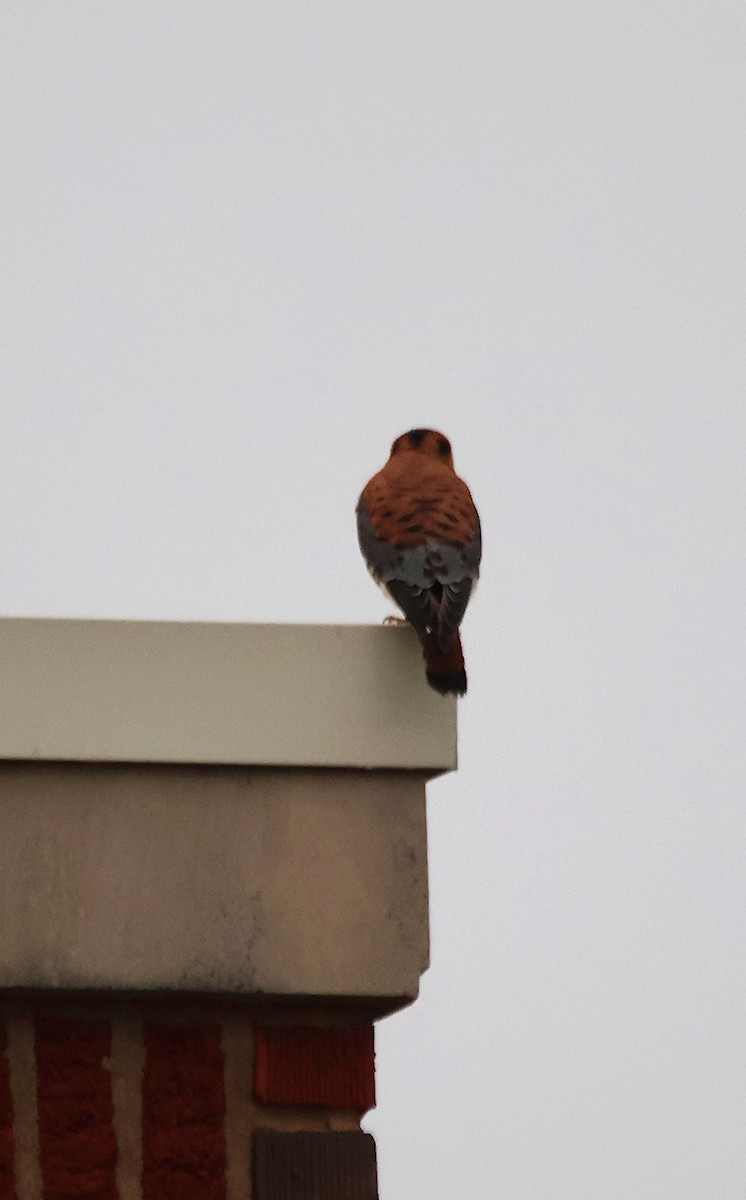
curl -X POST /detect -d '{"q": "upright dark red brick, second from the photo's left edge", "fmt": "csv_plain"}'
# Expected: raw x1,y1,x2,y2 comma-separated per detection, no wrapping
35,1019,118,1200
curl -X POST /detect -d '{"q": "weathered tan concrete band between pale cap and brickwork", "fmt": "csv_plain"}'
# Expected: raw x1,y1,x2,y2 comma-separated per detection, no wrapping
0,762,428,1007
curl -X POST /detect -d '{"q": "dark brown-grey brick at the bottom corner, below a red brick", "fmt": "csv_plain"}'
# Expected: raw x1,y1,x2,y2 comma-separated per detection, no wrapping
252,1129,378,1200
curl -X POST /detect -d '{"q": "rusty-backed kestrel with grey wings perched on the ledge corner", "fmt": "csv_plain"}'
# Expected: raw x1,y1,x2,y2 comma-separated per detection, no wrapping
357,430,482,696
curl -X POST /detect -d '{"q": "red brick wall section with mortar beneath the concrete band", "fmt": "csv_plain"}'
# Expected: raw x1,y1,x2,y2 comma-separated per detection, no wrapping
0,1009,378,1200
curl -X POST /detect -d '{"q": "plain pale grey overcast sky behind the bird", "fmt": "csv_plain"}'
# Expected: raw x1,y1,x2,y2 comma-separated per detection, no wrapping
0,0,746,1200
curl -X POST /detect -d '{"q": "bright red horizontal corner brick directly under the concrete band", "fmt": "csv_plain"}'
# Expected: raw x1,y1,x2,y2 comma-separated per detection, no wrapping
254,1025,375,1112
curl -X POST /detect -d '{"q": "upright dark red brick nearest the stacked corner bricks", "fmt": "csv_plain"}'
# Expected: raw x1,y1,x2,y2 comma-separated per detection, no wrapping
143,1022,225,1200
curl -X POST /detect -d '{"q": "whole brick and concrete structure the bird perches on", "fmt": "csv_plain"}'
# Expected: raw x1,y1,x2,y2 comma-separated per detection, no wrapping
0,619,456,1200
